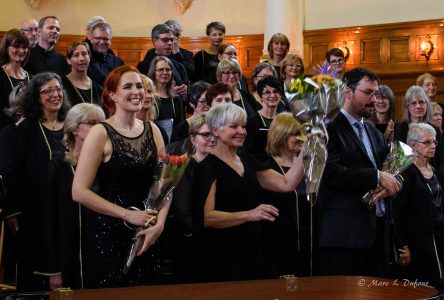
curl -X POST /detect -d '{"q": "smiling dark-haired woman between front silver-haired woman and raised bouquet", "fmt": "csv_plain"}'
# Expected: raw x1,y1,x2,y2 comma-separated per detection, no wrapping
244,76,282,161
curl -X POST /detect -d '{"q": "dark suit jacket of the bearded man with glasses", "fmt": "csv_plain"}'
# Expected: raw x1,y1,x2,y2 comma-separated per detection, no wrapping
318,113,389,249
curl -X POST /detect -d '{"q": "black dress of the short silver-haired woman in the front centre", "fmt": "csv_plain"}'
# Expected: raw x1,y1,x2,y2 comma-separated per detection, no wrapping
193,154,262,281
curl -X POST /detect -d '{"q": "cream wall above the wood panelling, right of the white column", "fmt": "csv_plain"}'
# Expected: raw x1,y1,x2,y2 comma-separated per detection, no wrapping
305,0,444,30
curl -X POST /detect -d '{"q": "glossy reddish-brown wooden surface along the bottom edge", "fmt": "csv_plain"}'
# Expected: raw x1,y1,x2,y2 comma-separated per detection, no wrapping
50,276,437,300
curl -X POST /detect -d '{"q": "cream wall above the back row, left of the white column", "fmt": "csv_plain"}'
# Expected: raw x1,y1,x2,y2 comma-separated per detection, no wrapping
0,0,264,37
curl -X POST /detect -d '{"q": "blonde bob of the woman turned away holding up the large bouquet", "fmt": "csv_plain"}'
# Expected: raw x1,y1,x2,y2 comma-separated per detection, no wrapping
265,112,302,156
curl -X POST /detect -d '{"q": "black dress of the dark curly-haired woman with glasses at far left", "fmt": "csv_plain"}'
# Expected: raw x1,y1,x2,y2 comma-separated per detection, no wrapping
4,116,65,291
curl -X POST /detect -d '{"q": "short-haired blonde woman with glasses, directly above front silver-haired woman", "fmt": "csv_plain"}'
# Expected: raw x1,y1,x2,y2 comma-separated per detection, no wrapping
216,59,260,116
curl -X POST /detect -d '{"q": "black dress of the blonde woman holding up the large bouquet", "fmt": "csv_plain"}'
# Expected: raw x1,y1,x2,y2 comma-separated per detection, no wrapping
264,157,316,278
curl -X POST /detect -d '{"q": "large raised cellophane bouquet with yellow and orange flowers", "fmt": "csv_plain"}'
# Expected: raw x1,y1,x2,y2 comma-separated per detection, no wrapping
288,67,346,206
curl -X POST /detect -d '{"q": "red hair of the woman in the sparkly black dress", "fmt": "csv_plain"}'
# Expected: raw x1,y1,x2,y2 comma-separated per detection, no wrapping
101,65,140,116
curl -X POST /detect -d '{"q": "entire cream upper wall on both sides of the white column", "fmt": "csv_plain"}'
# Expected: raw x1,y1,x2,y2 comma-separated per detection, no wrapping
0,0,444,37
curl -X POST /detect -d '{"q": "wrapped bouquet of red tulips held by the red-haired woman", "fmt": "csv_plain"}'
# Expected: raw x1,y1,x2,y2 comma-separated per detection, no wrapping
123,148,190,275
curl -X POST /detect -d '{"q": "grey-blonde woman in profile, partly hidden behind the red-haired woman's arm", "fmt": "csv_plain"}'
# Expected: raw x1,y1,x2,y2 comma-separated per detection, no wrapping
41,103,105,290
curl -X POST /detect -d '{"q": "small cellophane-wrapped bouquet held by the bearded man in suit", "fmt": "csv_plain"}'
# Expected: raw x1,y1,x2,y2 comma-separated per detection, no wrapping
362,141,415,208
